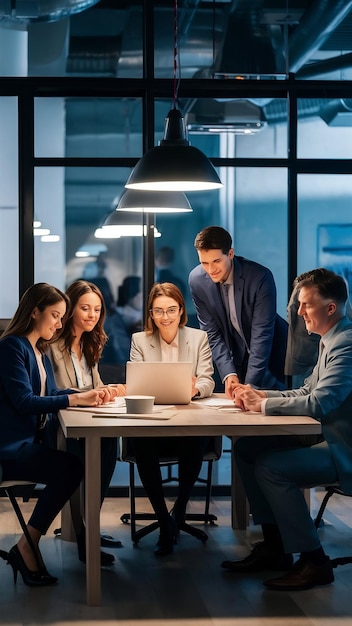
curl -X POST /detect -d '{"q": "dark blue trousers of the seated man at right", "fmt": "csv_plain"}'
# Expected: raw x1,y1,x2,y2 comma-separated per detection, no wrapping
234,435,338,553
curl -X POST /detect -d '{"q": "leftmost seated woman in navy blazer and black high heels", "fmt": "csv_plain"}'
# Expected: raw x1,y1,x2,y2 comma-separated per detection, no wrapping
0,283,110,586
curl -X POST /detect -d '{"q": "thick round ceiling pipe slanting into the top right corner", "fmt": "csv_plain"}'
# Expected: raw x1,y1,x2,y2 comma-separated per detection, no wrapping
288,0,352,73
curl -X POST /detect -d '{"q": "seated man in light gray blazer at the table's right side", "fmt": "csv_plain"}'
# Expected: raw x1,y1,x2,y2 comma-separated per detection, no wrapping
222,268,352,591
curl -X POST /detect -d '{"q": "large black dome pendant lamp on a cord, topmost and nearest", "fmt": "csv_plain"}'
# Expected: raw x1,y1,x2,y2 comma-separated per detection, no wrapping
125,0,222,191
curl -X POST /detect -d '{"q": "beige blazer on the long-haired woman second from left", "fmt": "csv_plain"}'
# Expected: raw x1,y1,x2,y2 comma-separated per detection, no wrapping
47,340,104,391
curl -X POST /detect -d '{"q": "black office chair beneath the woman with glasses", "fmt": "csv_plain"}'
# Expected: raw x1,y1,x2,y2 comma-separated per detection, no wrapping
119,436,222,544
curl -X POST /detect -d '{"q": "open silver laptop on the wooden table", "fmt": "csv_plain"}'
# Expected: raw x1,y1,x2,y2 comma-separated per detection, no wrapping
126,361,193,404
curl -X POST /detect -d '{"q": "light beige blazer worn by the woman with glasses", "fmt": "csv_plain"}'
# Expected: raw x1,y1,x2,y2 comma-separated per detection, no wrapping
130,326,215,398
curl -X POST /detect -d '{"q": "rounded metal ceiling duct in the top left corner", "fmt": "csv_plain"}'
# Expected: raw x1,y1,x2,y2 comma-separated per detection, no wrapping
0,0,99,26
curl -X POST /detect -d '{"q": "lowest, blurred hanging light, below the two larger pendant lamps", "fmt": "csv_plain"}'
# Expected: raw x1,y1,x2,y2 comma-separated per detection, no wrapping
94,210,161,239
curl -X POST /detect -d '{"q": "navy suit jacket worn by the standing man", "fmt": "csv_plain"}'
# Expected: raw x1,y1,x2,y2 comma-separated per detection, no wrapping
189,256,288,389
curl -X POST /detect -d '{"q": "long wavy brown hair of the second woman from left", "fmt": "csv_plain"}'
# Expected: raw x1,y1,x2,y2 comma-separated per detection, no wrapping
56,280,108,367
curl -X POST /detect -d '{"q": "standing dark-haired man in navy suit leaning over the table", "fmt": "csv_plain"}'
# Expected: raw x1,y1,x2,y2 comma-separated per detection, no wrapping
189,226,288,398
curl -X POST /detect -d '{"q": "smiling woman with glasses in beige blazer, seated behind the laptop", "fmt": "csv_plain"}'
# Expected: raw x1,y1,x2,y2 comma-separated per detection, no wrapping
130,283,214,556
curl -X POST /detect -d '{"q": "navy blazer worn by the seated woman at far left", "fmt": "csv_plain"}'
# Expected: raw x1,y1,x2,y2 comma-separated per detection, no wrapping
0,335,74,461
